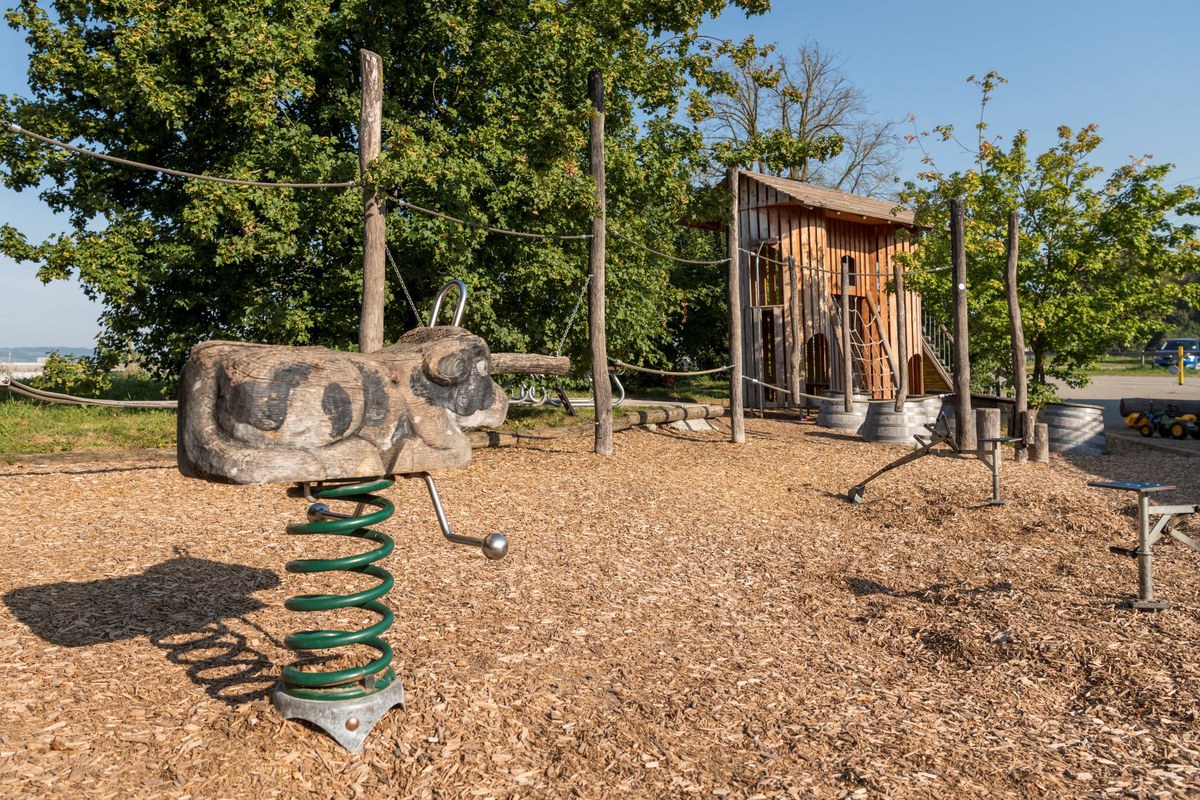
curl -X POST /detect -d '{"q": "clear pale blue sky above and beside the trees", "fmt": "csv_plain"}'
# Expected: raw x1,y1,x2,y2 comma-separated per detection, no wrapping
0,0,1200,348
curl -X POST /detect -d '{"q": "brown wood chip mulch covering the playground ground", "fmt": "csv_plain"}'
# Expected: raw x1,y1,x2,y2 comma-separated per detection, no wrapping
0,420,1200,800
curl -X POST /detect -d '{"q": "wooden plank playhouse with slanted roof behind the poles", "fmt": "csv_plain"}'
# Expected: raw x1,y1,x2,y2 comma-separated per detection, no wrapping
737,172,949,408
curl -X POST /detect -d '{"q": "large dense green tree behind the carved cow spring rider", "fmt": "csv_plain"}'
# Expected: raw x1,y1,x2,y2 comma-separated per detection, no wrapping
0,0,769,381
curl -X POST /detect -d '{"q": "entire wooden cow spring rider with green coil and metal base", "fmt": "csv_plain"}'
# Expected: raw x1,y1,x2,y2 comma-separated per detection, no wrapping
172,282,552,751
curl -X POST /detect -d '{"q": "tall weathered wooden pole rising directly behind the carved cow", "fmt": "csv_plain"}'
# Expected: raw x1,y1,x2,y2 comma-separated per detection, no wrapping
359,50,388,353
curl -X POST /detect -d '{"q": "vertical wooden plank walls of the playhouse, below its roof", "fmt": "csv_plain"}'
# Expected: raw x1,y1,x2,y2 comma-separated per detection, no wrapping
738,175,924,408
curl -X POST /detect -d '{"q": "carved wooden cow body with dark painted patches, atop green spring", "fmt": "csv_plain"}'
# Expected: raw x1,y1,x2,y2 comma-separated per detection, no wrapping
179,325,508,483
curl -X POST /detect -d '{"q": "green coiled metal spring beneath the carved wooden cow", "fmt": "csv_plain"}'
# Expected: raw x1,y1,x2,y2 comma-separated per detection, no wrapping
283,479,396,700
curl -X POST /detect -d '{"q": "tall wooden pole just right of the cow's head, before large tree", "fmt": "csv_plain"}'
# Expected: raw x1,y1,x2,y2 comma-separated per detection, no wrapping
588,70,612,456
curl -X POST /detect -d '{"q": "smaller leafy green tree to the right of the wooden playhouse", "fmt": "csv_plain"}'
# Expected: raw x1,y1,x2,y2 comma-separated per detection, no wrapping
901,73,1200,397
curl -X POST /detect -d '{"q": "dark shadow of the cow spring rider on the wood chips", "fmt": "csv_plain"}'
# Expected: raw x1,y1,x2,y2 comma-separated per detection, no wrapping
4,555,280,705
